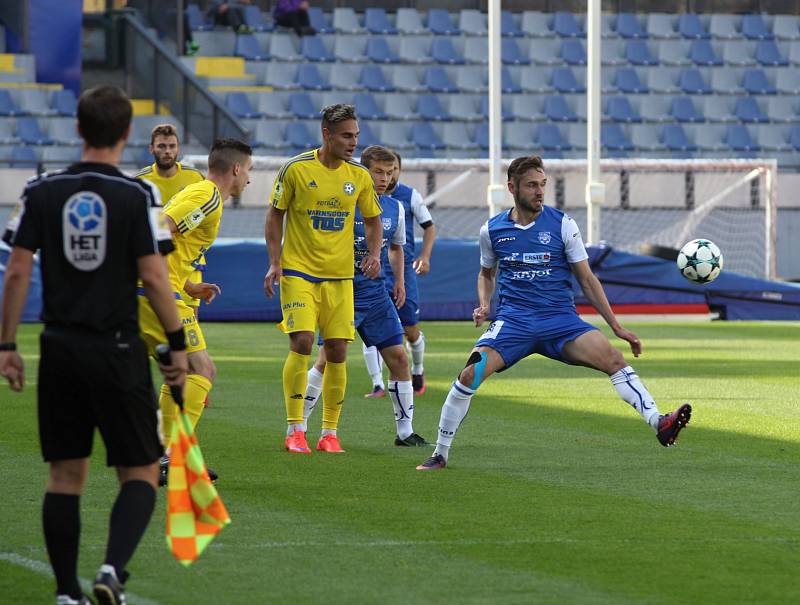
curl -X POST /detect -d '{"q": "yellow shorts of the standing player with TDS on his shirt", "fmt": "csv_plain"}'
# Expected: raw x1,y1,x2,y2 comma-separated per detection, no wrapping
278,276,355,340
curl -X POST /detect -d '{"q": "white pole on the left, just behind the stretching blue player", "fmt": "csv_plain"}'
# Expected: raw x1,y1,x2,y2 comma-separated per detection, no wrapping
486,0,505,216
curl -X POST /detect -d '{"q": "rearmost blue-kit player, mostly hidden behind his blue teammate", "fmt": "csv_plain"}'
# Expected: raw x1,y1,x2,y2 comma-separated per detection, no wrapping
363,151,436,397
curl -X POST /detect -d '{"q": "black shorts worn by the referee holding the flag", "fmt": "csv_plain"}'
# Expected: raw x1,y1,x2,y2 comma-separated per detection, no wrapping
38,327,163,466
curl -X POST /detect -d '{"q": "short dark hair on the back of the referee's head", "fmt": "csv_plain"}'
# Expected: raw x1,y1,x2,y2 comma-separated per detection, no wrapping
78,85,133,148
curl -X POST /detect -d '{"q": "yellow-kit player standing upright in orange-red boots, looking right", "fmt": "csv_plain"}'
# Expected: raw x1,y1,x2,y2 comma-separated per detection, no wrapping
264,104,383,453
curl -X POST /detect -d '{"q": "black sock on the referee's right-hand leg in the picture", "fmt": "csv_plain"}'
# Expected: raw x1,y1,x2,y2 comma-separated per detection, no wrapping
105,480,156,580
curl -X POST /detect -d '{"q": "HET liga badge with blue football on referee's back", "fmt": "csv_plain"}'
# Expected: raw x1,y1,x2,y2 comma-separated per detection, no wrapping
62,191,107,271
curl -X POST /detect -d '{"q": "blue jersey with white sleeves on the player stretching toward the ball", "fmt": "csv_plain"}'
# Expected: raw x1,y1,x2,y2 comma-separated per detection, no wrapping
480,206,589,315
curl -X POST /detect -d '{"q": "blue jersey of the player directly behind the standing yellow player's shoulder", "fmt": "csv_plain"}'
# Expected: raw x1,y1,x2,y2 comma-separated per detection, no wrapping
353,195,405,307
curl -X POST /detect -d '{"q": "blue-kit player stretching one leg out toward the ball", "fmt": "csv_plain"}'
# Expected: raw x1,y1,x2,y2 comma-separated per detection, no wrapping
417,156,692,470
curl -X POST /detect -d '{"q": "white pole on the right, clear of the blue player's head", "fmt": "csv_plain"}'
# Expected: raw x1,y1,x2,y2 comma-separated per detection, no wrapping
586,0,606,244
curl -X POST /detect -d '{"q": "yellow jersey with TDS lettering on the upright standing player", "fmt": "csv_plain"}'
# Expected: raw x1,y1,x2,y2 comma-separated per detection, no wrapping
271,149,381,281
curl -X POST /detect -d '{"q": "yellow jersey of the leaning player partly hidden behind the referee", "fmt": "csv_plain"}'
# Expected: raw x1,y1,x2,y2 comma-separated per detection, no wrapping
164,180,222,292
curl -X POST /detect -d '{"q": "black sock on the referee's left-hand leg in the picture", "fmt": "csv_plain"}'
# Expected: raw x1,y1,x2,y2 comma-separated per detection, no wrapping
42,492,83,599
